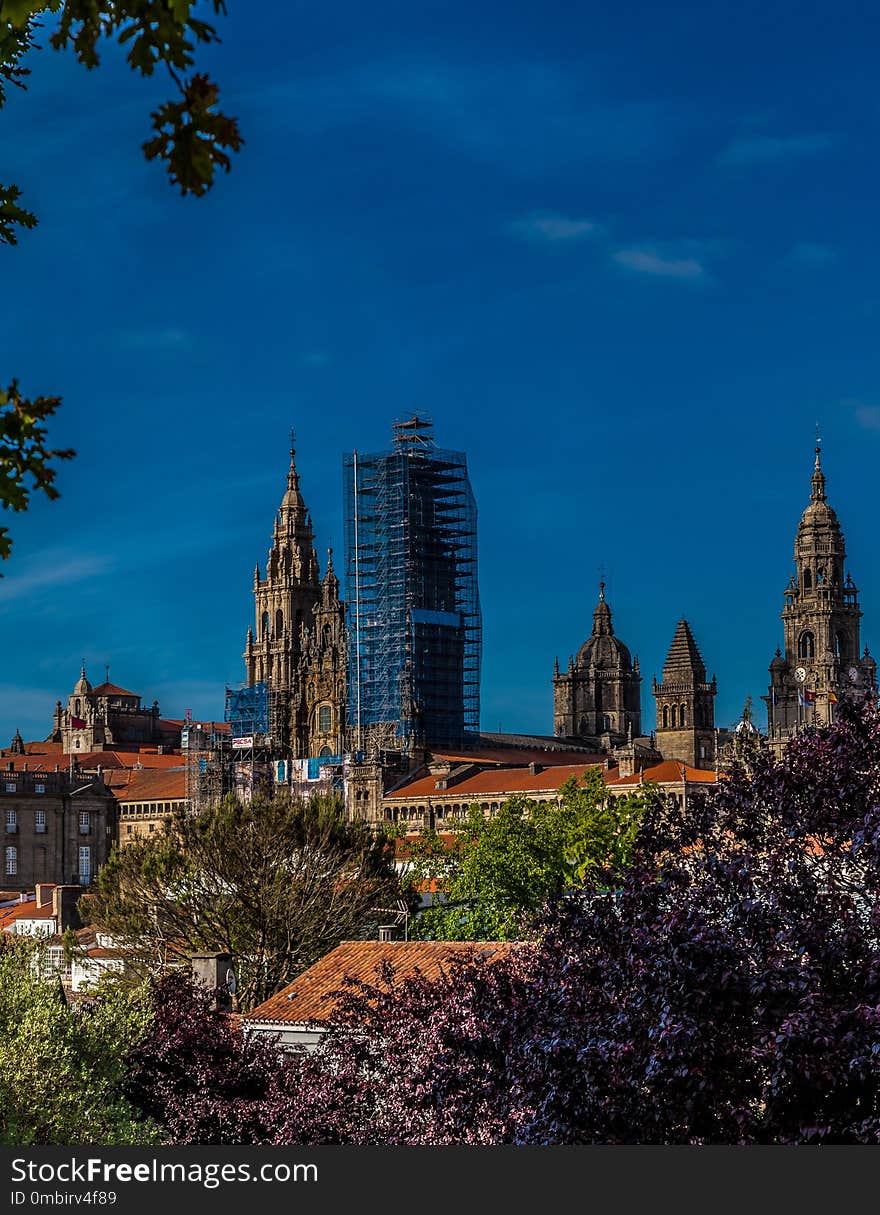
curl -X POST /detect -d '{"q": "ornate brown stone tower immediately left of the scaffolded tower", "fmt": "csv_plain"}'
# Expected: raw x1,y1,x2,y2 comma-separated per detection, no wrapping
244,443,346,759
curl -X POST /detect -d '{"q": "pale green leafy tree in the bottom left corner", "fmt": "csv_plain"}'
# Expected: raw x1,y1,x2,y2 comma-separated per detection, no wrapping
0,938,162,1145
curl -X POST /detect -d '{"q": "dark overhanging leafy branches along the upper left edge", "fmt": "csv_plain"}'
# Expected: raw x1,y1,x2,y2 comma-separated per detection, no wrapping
0,0,243,560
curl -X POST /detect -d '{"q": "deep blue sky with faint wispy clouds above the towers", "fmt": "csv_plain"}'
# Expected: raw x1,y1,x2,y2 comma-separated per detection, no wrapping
0,0,880,744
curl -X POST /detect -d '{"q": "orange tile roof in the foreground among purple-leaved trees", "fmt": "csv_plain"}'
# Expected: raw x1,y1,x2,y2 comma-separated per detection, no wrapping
243,940,517,1024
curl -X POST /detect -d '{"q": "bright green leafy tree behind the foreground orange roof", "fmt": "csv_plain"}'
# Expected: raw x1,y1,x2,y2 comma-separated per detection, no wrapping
406,769,650,940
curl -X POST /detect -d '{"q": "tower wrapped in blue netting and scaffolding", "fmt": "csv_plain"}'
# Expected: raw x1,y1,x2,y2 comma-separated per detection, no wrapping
344,417,483,751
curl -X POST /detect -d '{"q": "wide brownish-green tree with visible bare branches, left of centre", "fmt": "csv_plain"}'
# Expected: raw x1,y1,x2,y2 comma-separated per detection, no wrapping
80,797,399,1008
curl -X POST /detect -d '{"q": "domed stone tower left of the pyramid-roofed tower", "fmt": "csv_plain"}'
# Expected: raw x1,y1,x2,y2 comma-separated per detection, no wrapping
553,582,642,750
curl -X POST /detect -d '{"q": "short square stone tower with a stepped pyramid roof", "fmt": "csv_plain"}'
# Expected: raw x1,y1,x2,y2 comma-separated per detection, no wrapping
654,620,717,768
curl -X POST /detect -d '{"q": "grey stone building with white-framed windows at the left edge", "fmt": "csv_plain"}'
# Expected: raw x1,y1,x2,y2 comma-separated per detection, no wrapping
0,761,118,891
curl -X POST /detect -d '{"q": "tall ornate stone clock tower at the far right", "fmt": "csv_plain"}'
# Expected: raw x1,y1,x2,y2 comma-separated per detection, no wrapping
763,442,878,748
